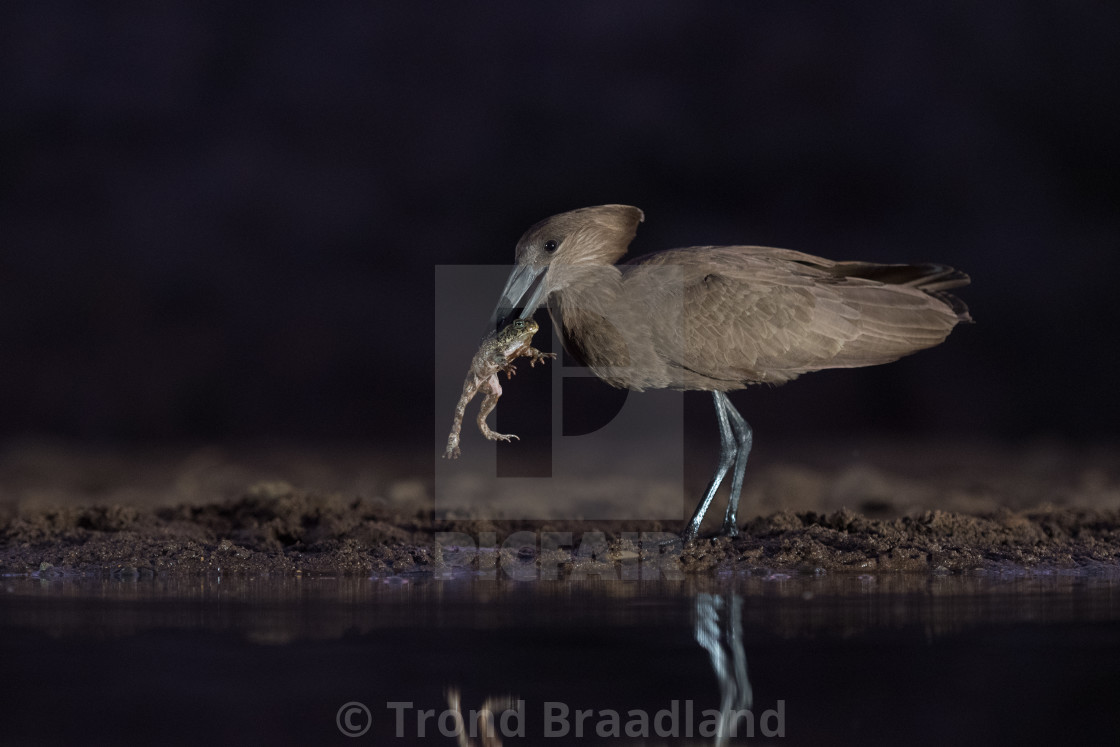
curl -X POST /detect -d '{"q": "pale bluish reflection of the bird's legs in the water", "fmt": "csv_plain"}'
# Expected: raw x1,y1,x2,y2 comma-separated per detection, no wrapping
694,594,754,745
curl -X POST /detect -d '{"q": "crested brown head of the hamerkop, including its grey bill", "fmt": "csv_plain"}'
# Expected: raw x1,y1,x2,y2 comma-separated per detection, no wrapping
491,205,645,329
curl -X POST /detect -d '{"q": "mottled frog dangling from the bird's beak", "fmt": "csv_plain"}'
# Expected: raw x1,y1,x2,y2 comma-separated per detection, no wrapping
444,319,557,459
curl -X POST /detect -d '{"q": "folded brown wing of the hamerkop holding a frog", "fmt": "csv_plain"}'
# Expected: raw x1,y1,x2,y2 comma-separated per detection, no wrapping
624,246,967,387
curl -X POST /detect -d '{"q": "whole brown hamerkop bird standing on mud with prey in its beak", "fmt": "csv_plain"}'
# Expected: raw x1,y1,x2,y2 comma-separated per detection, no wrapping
491,205,970,541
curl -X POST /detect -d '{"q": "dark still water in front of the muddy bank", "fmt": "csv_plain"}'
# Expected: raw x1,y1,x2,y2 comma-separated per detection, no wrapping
0,571,1120,745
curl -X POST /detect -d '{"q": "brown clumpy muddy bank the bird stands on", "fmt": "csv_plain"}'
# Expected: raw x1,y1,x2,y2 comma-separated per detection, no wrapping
0,442,1120,578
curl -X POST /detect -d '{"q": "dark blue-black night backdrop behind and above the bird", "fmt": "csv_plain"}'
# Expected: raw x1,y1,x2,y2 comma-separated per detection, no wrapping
0,1,1120,450
